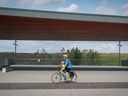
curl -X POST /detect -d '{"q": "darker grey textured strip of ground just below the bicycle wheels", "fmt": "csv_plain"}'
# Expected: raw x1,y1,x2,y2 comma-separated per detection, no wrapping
0,82,128,90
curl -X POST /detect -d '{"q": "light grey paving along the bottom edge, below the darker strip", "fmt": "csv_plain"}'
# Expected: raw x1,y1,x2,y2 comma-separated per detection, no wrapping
0,89,128,96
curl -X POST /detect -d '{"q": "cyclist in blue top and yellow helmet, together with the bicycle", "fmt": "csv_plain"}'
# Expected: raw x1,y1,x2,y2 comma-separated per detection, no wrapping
51,54,77,82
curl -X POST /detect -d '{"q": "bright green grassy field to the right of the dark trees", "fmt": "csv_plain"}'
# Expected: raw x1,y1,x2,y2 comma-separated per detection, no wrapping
81,53,128,66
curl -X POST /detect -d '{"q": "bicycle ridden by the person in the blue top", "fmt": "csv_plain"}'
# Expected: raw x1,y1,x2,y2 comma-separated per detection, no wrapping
51,67,77,83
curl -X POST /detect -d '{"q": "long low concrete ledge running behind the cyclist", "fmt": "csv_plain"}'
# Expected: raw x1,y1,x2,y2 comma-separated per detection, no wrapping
11,65,128,71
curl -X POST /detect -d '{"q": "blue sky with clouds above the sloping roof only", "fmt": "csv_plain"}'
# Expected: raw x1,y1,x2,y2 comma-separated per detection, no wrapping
0,0,128,16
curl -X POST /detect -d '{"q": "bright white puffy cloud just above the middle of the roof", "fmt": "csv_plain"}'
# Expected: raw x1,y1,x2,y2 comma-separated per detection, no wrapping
57,4,79,12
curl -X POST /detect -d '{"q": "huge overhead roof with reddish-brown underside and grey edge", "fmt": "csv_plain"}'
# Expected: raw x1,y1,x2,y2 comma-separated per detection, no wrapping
0,8,128,41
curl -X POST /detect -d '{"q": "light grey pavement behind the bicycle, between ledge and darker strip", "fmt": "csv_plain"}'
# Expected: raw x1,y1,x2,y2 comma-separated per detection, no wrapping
0,71,128,83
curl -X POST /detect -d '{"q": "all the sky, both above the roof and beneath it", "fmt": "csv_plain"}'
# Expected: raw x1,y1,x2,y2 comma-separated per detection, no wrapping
0,0,128,53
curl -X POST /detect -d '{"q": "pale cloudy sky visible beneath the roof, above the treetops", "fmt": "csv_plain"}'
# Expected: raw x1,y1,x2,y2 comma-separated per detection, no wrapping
0,40,128,53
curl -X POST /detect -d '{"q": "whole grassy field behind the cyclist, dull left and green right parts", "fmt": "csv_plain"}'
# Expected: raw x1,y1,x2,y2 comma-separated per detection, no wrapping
0,53,128,66
